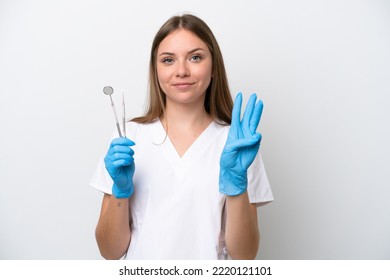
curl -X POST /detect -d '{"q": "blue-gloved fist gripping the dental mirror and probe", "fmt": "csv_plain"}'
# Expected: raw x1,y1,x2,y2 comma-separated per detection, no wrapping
104,137,135,198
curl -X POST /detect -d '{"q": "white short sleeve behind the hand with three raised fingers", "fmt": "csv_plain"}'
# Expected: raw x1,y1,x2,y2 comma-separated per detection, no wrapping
248,152,274,207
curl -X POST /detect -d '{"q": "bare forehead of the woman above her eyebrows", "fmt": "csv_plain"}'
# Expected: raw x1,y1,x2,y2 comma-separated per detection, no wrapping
158,29,208,53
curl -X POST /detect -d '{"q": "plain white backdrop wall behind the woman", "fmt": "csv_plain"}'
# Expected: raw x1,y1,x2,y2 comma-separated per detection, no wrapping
0,0,390,259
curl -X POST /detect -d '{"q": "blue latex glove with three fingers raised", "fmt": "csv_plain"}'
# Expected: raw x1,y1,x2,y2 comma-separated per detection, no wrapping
219,93,263,196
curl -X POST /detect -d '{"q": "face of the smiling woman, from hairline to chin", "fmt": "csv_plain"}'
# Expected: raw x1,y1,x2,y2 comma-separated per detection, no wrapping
156,29,212,105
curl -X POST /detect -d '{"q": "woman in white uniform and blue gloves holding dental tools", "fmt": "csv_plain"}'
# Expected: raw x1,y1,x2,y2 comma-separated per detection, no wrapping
91,12,273,259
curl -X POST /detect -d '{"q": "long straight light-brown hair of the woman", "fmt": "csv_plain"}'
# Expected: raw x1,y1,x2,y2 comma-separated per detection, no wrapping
132,14,233,124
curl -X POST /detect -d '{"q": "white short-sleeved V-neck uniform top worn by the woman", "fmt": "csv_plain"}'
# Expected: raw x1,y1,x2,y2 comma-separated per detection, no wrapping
91,120,273,260
